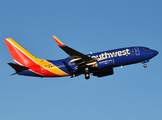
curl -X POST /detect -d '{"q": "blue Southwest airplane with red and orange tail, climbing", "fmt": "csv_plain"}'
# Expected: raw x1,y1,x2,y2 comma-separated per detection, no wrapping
4,36,158,79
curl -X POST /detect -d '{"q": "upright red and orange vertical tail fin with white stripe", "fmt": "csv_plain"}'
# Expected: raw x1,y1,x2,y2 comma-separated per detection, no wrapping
5,38,37,67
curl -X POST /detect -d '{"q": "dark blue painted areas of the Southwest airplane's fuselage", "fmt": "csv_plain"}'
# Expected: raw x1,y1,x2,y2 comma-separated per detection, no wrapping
18,46,158,77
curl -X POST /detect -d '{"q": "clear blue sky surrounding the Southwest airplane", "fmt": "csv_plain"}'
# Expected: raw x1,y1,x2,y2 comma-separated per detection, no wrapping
0,0,162,120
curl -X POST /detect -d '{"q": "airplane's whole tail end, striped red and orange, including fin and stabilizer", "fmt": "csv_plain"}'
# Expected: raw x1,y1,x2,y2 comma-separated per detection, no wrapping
5,38,69,77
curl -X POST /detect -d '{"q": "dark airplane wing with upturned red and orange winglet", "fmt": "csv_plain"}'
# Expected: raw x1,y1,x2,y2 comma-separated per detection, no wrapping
53,36,96,65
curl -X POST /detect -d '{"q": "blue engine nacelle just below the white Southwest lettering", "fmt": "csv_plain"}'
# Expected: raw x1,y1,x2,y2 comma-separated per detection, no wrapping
94,58,114,69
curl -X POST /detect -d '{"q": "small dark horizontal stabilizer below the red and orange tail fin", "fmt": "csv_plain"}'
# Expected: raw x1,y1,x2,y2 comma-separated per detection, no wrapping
8,63,30,75
